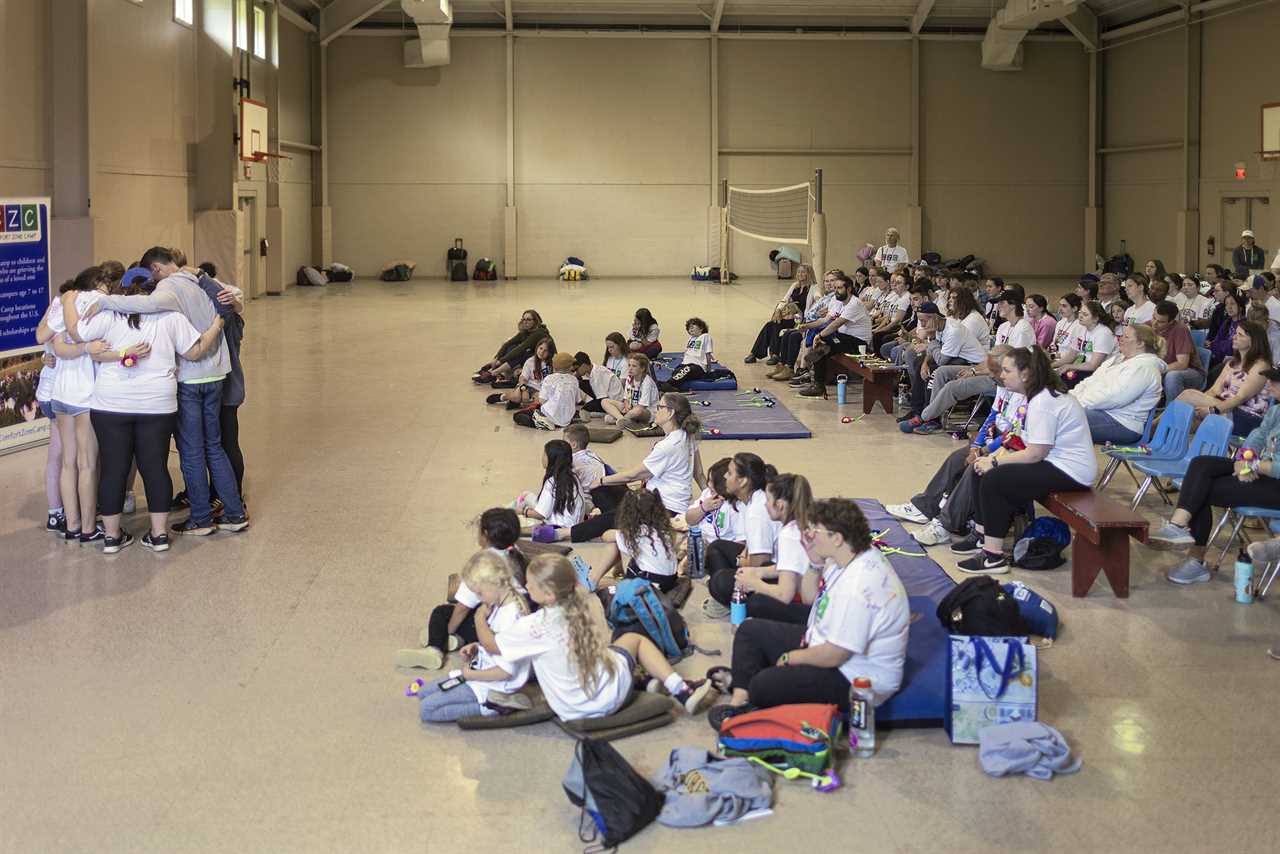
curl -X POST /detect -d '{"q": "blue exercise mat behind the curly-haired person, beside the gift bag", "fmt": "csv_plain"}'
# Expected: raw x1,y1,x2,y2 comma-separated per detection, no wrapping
858,498,956,729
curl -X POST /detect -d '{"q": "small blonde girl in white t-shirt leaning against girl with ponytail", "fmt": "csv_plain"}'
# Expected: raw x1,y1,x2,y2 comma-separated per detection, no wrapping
410,549,532,723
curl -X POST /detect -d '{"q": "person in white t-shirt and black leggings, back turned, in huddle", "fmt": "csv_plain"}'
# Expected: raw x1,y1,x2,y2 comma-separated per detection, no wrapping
76,287,223,554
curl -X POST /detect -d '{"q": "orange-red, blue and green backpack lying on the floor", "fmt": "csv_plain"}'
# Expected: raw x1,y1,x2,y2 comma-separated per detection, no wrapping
717,703,840,776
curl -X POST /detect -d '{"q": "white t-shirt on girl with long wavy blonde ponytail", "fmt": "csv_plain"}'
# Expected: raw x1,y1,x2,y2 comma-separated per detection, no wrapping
494,597,632,721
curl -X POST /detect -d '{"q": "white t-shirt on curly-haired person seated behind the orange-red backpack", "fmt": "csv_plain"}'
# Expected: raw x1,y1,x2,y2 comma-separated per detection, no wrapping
804,548,911,705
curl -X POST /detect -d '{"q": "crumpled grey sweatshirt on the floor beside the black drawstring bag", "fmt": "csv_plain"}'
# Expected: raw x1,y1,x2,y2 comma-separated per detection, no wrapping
653,748,773,827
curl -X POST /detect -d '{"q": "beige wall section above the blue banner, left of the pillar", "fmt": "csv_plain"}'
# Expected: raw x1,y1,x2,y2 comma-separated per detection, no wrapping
0,0,51,196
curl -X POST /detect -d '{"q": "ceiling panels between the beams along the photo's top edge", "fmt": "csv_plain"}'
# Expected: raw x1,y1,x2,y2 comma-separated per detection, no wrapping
280,0,1181,32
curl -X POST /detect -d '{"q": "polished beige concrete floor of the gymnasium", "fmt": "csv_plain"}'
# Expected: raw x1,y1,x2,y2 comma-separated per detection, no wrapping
0,280,1280,853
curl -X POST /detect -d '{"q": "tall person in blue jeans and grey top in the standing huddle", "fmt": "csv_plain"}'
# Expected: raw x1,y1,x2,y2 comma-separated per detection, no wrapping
86,246,248,536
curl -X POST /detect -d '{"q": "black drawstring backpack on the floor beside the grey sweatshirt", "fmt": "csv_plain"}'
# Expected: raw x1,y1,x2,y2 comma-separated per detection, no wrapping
561,739,663,850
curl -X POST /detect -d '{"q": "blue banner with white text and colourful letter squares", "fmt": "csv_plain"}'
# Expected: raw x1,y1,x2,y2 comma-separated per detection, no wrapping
0,197,52,453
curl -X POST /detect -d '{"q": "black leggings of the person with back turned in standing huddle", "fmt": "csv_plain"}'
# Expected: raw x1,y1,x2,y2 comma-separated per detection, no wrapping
90,410,178,516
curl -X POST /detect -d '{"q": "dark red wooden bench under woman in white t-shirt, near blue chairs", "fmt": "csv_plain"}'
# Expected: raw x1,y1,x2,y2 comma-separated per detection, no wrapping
1039,489,1147,599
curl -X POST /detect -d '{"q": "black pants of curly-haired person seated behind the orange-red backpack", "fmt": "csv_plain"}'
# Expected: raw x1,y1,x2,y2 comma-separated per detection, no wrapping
732,618,849,712
